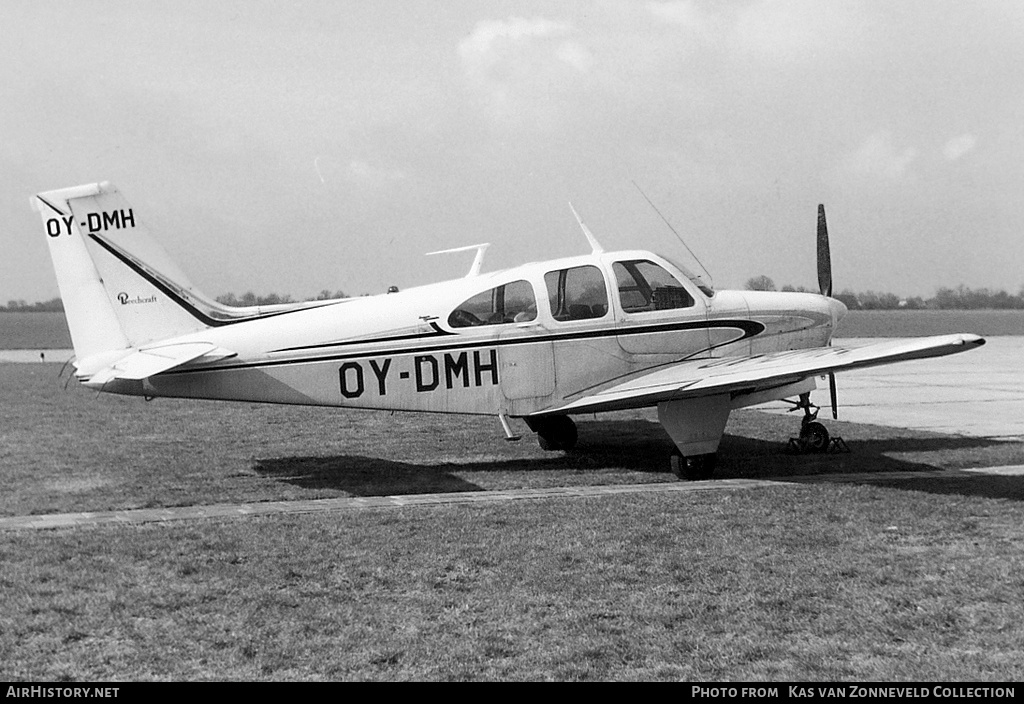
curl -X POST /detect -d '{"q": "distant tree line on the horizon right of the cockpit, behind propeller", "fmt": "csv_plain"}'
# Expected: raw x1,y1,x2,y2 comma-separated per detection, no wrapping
746,274,1024,310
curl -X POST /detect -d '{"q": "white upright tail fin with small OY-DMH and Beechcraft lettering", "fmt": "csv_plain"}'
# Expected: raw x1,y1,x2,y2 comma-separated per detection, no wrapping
33,182,211,359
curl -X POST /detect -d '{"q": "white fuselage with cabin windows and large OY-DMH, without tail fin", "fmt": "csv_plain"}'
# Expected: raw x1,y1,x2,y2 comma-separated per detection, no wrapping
94,251,846,416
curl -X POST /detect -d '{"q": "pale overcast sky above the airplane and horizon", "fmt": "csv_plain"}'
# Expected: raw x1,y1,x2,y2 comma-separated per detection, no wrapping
0,0,1024,303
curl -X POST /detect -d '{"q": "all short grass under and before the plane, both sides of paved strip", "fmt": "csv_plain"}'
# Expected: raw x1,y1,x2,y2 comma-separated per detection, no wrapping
0,364,1024,681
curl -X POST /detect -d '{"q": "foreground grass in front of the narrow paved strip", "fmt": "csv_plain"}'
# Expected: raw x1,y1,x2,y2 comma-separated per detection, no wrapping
6,486,1024,681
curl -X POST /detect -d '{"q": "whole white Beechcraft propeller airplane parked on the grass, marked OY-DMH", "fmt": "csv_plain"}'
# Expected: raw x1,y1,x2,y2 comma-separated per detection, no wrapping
32,182,985,479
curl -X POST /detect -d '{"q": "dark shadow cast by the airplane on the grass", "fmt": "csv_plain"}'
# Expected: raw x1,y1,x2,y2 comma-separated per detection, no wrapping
254,420,1024,500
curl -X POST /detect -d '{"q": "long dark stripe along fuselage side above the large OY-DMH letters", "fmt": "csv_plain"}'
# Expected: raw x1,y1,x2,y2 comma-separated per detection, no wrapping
162,319,765,376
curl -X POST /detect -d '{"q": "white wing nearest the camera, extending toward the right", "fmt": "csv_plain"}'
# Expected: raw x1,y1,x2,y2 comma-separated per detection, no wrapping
536,335,985,415
